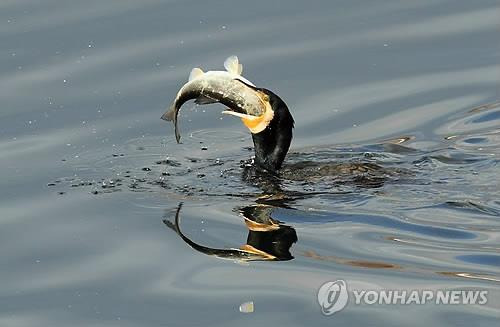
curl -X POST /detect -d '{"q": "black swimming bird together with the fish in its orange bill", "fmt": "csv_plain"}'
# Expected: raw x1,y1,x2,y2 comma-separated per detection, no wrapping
162,56,387,182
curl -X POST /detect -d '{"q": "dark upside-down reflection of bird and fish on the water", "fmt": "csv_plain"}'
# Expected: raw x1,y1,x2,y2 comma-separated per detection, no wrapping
163,203,297,261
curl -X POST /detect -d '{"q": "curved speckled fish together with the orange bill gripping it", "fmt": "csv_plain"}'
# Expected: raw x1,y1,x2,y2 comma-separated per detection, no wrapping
161,56,273,143
